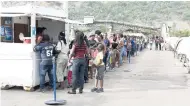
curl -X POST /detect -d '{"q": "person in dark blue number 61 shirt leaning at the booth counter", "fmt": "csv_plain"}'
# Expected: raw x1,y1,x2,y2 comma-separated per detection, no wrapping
34,35,55,92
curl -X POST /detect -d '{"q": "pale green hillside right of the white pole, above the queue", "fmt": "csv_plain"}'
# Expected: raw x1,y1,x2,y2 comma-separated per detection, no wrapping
69,1,190,25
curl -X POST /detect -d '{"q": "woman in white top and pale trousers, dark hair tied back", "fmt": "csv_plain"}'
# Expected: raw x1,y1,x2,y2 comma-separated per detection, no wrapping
56,32,69,89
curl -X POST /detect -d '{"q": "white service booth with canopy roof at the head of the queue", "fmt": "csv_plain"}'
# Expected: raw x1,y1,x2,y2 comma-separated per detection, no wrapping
0,5,83,89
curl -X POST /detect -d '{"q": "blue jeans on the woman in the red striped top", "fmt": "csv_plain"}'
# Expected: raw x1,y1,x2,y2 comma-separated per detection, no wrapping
72,58,86,92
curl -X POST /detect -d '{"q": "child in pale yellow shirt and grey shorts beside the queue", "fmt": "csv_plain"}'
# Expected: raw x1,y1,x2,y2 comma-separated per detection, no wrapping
91,44,105,93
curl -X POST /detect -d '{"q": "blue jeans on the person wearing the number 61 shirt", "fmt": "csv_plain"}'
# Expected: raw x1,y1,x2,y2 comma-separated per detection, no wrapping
40,64,53,89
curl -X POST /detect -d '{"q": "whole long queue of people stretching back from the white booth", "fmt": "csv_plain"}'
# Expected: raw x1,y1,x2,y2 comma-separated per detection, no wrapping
34,30,147,94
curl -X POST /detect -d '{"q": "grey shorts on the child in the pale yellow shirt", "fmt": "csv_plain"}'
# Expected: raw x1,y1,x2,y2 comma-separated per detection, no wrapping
95,66,105,80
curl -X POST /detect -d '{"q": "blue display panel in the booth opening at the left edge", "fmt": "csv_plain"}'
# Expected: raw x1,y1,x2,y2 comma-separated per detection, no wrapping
0,17,13,43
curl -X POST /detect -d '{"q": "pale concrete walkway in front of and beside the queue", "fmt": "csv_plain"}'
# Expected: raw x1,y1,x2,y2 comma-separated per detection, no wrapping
1,50,190,106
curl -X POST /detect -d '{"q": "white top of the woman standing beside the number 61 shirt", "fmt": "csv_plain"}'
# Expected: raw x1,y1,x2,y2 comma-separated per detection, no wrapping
56,40,69,54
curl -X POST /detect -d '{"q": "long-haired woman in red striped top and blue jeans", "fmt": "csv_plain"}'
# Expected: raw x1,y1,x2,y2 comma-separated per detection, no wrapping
68,31,88,94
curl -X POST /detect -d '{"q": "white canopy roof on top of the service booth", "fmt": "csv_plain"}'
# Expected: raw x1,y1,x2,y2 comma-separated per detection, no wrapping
0,4,84,25
